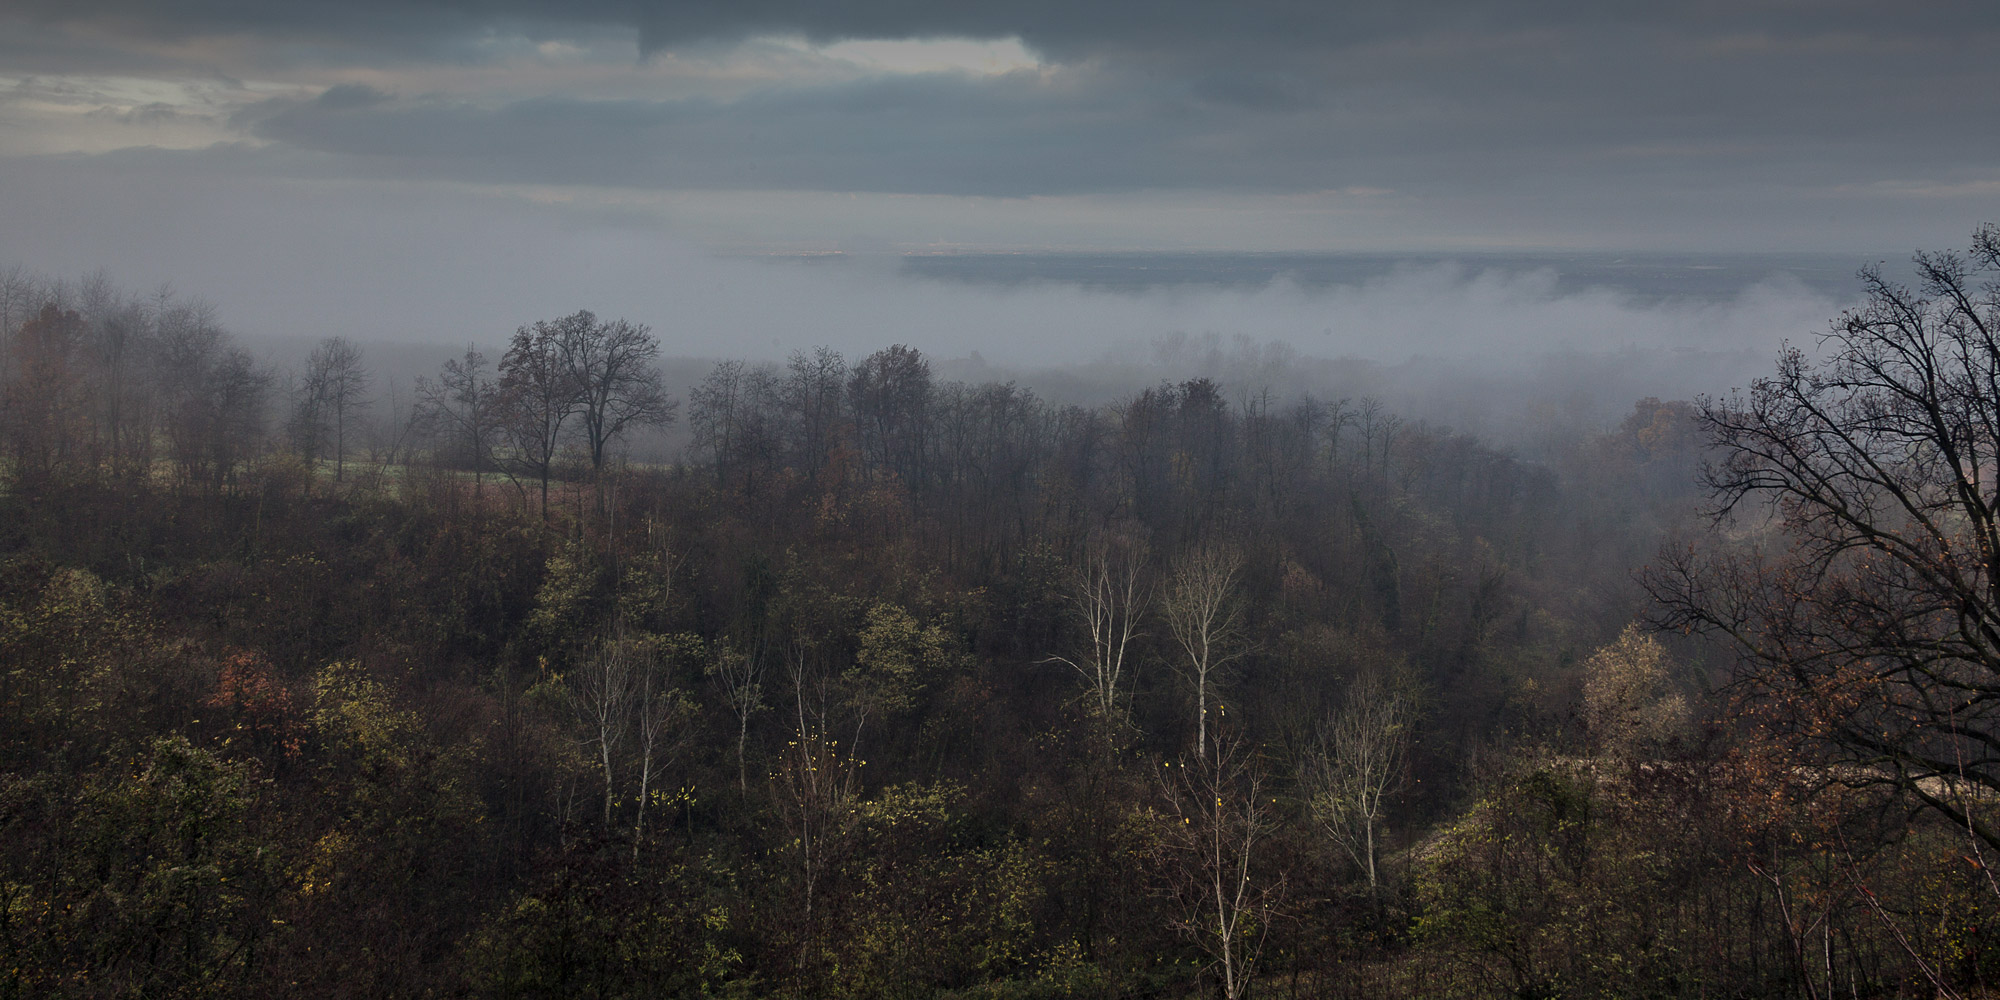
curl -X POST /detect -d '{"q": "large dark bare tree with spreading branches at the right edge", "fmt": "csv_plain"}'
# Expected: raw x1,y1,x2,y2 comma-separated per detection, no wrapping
1646,226,2000,846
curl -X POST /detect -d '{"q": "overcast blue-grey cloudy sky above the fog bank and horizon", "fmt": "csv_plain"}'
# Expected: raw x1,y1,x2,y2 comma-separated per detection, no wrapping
0,0,2000,250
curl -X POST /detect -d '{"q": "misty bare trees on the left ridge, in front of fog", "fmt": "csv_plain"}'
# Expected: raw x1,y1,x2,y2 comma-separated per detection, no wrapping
0,268,678,508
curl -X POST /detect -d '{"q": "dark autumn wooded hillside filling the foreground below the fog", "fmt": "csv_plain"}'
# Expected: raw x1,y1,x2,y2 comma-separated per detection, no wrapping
0,228,2000,1000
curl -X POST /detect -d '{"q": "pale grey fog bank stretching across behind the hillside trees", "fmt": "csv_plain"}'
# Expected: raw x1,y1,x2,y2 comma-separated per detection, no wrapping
11,162,1856,454
